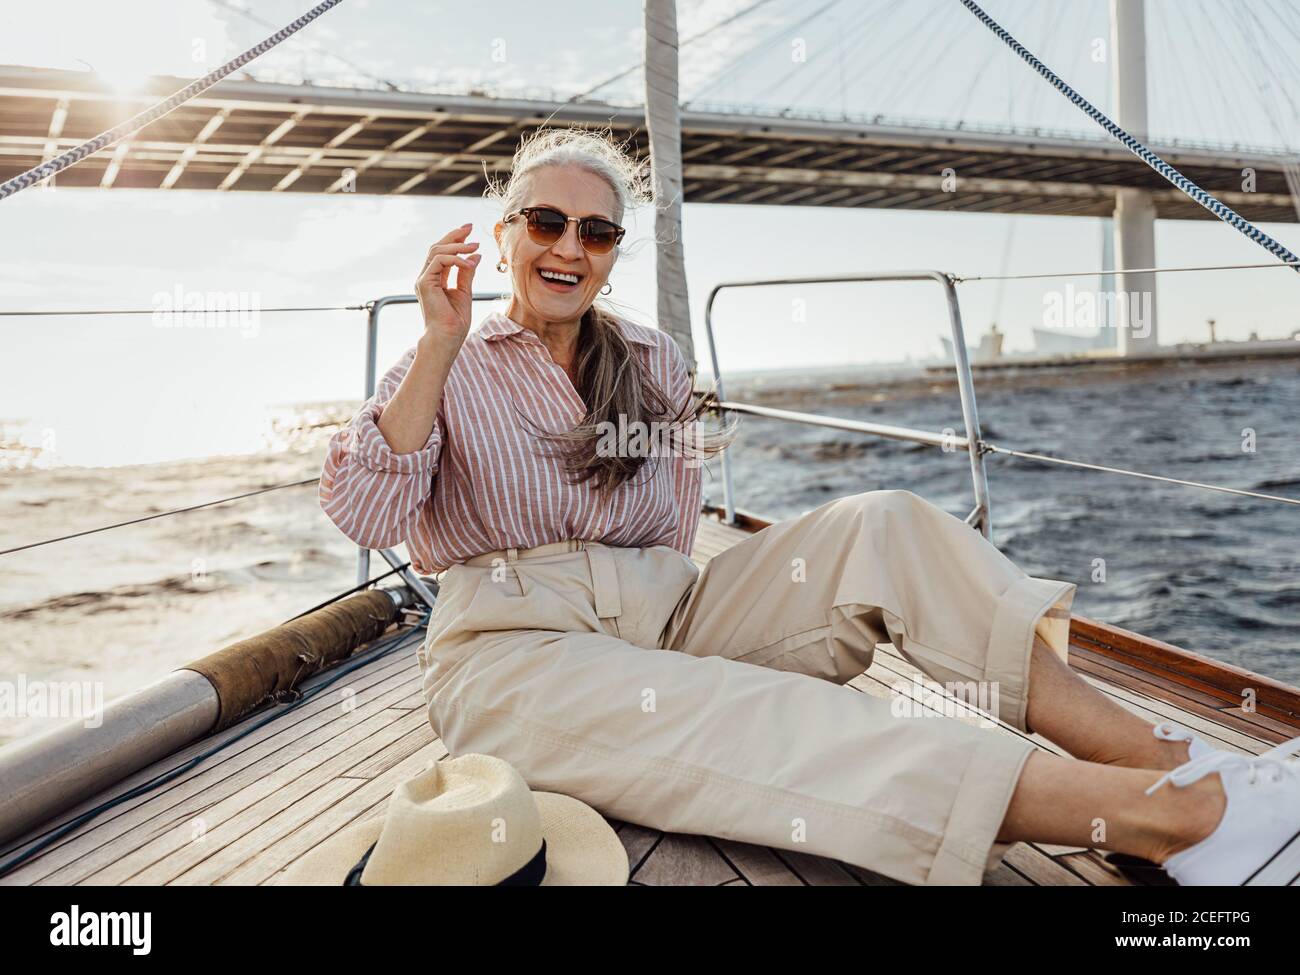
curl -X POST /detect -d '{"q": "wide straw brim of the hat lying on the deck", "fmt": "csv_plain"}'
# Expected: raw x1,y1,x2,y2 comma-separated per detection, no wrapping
276,792,628,887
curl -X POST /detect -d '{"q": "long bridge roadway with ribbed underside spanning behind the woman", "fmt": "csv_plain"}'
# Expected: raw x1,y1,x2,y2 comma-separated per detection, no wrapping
0,66,1297,222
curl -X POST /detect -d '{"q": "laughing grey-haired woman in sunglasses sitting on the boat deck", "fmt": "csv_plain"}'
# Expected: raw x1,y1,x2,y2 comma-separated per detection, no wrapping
321,130,1300,884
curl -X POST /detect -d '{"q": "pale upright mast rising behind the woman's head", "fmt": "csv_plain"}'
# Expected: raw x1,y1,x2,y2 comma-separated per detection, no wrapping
645,0,696,377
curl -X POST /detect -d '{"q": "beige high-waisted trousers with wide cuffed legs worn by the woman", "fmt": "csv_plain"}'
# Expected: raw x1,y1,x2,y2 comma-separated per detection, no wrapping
419,490,1075,884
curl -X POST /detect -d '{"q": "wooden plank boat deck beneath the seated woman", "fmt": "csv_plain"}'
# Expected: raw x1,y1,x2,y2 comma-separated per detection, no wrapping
0,517,1300,887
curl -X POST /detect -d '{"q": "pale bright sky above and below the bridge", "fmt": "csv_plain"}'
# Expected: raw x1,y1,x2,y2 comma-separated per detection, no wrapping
0,0,1300,464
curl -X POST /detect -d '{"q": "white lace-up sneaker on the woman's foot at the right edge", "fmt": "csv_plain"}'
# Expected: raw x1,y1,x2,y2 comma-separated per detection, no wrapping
1147,732,1300,887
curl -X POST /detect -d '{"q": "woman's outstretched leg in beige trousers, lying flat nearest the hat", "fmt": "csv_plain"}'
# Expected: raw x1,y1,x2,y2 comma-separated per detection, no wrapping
421,535,1227,884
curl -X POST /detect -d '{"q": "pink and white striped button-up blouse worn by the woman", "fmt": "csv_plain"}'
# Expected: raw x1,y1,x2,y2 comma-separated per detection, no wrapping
320,312,701,575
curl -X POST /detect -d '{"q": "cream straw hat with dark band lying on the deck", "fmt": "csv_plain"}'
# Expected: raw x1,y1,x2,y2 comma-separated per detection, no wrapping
280,754,628,887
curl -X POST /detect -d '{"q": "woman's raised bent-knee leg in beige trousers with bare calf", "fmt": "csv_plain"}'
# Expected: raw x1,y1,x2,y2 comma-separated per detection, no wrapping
681,491,1187,770
